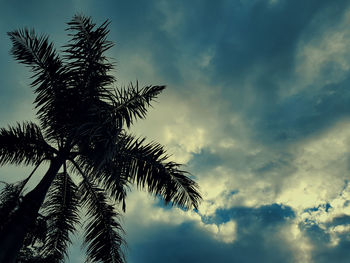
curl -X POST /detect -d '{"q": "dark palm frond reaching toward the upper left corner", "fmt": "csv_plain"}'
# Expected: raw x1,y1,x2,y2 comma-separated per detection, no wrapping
8,29,68,140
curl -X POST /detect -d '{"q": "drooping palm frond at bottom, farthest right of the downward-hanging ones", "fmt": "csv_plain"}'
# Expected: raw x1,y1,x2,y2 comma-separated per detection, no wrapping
79,170,125,263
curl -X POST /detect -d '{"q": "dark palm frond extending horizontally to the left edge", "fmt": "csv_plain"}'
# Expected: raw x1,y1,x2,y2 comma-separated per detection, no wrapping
0,122,55,165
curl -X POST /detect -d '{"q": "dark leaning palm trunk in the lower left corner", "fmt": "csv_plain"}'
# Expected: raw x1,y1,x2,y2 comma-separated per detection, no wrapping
0,157,64,263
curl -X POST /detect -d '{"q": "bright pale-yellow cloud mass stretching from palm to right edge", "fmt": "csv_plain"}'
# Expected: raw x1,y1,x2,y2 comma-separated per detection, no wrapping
128,79,350,258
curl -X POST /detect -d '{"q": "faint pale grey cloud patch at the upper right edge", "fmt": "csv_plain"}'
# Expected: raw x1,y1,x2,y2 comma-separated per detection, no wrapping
289,11,350,96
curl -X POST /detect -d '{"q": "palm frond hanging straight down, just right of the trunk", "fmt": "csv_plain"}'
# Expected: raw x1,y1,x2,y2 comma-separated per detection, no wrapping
42,171,79,262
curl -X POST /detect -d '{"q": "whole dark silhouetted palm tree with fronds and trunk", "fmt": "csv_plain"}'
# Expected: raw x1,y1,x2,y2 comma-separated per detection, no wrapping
0,15,201,263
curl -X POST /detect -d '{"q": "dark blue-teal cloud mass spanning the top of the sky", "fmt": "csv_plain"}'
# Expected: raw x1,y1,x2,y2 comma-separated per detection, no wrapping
1,0,348,136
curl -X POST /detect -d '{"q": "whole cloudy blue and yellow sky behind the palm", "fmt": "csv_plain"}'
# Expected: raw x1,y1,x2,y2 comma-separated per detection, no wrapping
0,0,350,263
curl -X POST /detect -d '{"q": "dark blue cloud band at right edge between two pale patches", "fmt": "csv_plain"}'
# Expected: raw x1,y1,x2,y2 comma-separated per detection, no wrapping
256,77,350,142
